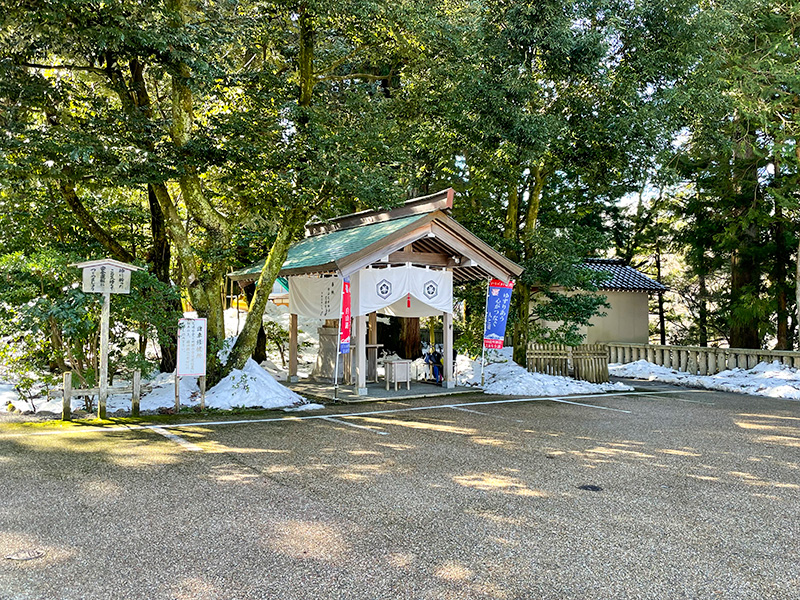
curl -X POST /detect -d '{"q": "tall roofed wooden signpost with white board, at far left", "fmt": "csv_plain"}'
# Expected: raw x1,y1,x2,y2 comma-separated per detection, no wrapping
73,258,141,419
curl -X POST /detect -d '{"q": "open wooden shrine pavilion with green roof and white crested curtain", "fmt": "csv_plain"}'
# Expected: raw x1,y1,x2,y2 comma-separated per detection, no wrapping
229,188,522,395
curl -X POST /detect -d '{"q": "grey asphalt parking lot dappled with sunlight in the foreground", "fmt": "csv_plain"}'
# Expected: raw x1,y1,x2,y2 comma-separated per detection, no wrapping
0,384,800,600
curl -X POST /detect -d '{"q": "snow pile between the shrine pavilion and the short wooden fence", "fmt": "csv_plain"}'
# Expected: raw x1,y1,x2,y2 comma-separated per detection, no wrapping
456,348,633,396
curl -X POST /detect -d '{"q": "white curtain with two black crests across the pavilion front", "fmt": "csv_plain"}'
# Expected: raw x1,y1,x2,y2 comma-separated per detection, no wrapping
352,266,453,317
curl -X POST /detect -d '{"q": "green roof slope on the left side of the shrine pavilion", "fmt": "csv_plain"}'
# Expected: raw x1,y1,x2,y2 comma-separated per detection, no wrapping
230,214,427,277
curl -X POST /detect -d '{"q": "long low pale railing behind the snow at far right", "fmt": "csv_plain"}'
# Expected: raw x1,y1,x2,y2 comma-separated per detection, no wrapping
607,343,800,375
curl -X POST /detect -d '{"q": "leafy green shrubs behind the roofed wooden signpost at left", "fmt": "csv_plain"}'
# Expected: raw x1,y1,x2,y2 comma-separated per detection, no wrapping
0,251,179,389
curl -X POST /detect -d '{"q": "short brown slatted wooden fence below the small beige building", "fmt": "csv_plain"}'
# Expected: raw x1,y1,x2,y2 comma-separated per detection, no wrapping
527,344,608,383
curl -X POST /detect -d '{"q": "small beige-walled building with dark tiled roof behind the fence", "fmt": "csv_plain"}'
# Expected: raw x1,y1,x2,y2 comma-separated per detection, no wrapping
583,258,667,344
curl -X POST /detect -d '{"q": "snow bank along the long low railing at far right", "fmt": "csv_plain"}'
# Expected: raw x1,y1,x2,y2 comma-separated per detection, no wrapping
608,360,800,400
